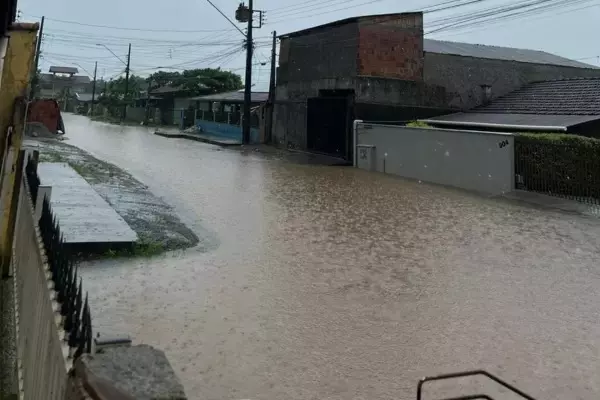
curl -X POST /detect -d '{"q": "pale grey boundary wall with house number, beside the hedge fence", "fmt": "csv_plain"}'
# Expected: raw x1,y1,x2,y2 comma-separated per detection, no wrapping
356,123,514,195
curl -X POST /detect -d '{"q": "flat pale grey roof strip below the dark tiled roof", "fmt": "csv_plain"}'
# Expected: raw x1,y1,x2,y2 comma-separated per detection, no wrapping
423,112,600,131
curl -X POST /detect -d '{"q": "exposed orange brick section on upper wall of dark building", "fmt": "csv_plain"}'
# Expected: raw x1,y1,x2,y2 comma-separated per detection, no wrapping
358,12,423,81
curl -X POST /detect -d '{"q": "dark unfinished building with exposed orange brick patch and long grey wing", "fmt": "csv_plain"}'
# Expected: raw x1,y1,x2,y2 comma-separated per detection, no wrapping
272,12,600,160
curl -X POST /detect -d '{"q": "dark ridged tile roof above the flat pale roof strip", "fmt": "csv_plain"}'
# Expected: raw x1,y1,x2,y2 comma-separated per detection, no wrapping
473,78,600,115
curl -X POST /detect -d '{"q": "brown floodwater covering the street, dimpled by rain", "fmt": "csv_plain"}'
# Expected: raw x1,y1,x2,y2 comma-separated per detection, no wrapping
65,115,600,400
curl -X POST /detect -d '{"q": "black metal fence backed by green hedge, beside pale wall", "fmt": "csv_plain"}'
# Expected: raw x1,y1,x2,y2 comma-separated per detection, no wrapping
515,137,600,205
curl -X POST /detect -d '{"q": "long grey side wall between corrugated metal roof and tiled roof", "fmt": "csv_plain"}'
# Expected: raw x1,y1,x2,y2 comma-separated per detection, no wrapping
424,53,600,108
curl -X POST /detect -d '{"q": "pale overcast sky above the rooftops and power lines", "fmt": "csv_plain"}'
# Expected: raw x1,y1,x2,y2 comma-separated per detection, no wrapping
19,0,600,89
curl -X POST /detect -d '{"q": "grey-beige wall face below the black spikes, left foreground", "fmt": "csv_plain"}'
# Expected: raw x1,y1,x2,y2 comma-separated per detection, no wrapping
11,177,71,400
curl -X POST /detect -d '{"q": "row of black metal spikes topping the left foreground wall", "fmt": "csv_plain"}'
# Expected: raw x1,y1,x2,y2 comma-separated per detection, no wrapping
25,158,92,359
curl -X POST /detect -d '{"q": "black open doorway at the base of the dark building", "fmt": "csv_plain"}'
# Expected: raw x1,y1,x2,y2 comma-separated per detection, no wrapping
306,93,354,161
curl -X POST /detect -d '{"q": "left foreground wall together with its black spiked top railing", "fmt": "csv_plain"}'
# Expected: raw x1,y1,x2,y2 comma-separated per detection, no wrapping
12,160,92,400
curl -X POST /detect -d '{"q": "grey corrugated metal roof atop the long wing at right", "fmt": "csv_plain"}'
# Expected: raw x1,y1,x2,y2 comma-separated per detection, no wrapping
423,39,599,69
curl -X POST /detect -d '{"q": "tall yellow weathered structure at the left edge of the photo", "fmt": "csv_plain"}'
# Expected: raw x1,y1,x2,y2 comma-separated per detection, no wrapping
0,23,39,276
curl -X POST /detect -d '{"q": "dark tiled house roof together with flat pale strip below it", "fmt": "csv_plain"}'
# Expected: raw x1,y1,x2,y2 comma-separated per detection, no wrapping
423,78,600,137
